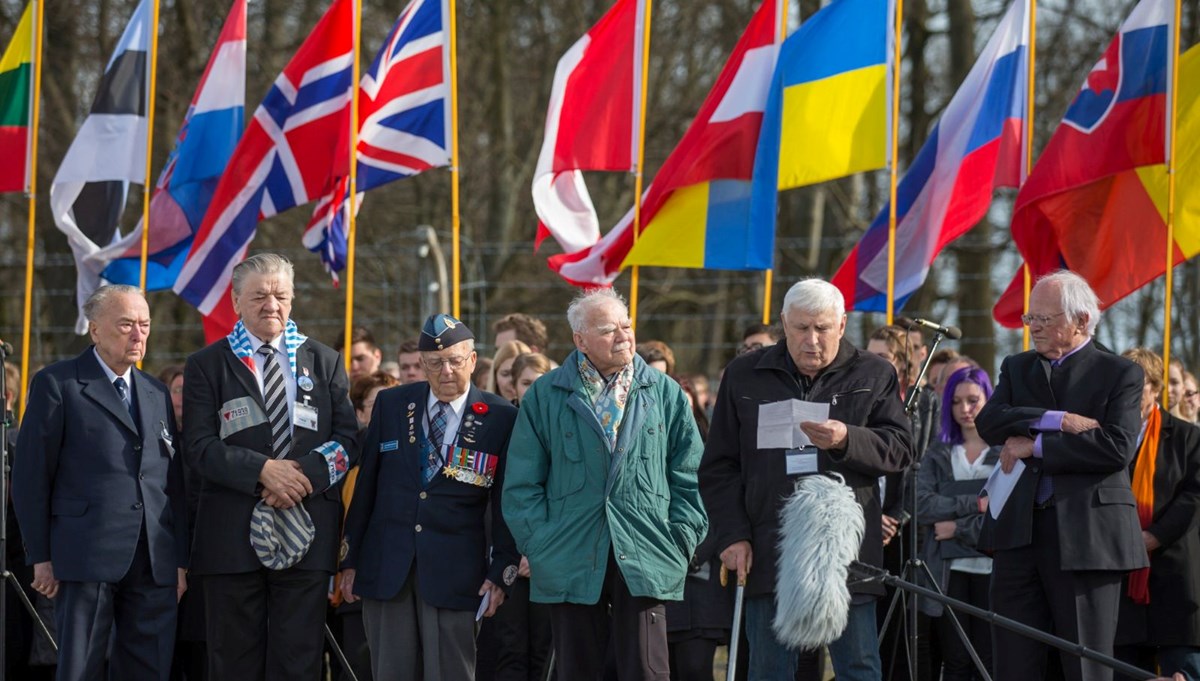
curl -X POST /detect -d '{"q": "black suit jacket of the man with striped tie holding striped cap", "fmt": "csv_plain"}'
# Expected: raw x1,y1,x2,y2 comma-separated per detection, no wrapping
184,338,358,574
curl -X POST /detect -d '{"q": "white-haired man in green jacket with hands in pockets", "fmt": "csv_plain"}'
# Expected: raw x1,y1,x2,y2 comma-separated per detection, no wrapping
503,289,708,681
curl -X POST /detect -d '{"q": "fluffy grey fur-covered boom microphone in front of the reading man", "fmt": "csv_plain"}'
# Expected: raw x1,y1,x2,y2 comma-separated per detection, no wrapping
772,474,865,650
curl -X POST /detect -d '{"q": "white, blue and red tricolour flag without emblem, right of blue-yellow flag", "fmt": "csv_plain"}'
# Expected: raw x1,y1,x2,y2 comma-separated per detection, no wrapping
833,0,1031,312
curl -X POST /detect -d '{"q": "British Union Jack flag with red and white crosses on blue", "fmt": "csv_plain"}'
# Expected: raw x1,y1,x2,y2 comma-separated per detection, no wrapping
304,0,451,281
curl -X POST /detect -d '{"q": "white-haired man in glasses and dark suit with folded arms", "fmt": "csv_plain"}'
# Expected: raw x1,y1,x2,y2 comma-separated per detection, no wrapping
976,271,1147,681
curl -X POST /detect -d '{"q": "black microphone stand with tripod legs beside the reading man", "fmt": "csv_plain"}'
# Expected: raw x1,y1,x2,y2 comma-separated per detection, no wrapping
880,331,991,681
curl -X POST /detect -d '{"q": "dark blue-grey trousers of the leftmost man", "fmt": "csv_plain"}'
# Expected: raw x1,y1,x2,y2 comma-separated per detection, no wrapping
54,529,176,681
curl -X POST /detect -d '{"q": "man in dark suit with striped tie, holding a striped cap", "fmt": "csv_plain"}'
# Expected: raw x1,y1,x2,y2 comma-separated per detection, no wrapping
177,253,358,681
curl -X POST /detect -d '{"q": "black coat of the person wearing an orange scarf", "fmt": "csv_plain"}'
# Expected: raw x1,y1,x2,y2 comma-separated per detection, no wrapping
1116,411,1200,646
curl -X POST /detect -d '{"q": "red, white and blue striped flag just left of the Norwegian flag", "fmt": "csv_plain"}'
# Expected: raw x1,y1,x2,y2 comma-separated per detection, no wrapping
88,0,246,326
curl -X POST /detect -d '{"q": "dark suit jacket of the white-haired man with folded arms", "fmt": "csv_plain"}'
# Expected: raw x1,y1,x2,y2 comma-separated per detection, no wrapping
976,342,1147,569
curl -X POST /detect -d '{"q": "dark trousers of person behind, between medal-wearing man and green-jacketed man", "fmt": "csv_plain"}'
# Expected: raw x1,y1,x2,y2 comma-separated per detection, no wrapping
492,577,550,681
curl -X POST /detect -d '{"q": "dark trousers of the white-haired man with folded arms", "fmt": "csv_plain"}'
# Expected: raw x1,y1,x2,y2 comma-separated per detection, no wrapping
991,507,1123,681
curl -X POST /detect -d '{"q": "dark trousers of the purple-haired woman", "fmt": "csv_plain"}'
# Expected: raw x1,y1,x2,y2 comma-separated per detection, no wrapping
937,569,991,681
